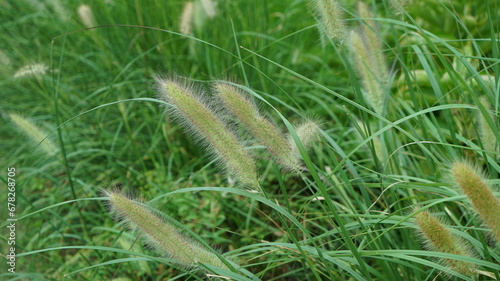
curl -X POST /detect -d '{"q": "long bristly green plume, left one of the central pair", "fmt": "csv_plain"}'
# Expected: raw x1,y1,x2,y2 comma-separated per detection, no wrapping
155,77,260,187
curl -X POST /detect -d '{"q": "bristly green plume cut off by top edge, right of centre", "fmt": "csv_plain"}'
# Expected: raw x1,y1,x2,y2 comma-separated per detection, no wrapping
311,0,346,43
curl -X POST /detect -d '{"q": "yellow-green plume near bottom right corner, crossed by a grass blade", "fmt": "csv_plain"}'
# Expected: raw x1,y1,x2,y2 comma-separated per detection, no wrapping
415,211,477,276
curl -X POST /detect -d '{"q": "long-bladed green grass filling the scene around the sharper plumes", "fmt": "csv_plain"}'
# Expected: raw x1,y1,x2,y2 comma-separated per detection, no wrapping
0,0,500,280
